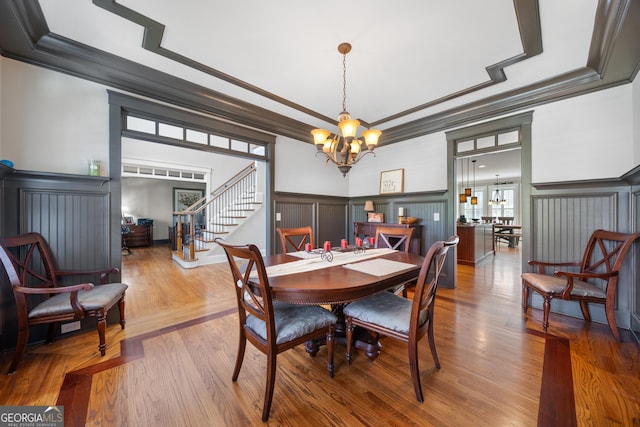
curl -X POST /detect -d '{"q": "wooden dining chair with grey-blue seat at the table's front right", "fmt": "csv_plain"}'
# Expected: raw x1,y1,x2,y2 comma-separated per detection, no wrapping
343,236,459,402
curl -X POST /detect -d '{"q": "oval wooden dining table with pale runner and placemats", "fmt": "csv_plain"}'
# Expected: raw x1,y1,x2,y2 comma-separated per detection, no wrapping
255,248,424,361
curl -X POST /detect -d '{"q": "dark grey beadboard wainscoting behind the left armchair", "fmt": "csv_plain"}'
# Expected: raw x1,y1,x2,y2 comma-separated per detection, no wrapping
0,171,121,349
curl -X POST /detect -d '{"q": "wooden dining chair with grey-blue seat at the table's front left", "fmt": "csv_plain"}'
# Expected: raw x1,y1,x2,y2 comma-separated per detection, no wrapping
216,239,338,421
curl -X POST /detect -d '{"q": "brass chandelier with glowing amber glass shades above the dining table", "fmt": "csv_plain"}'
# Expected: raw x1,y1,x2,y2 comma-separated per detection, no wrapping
311,43,382,176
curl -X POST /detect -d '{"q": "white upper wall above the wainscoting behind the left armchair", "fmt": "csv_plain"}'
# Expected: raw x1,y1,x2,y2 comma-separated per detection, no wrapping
0,58,109,175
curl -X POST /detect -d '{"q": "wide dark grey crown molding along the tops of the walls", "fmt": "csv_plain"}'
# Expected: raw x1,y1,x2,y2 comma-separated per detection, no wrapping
0,0,640,145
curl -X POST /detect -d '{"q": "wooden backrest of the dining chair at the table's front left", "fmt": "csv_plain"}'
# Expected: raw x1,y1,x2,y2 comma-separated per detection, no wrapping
215,239,276,346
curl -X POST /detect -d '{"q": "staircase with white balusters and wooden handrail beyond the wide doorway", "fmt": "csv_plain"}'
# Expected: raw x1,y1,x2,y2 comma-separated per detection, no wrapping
172,163,262,268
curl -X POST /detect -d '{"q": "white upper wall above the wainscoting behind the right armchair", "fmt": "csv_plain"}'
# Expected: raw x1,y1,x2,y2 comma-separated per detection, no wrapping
531,84,637,182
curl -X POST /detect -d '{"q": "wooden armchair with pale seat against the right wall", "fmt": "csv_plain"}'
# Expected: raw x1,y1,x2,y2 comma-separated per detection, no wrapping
522,230,640,341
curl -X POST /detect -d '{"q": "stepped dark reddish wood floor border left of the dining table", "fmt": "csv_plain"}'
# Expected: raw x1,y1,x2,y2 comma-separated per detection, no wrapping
56,308,238,427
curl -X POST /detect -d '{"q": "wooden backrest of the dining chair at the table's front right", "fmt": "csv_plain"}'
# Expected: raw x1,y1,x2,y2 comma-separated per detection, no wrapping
409,236,460,339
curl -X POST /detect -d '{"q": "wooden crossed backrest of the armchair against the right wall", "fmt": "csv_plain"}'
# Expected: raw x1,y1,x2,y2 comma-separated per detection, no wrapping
580,230,640,290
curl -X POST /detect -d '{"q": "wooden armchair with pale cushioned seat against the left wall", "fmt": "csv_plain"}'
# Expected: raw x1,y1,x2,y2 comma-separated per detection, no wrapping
0,233,127,373
